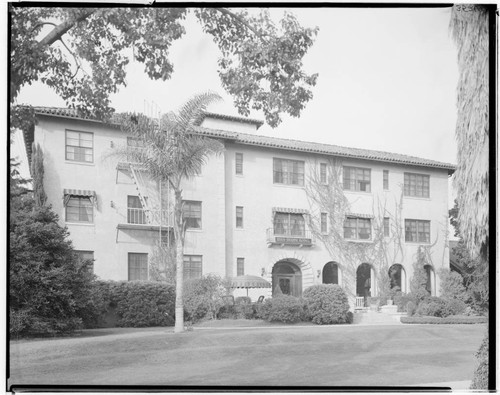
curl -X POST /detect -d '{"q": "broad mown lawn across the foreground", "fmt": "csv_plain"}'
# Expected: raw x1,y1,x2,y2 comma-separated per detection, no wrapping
9,324,486,386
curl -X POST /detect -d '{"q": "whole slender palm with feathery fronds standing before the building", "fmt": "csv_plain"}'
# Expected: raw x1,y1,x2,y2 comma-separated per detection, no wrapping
115,92,224,333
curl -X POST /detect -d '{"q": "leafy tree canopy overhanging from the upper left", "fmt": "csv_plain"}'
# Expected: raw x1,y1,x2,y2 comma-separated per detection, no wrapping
10,4,318,127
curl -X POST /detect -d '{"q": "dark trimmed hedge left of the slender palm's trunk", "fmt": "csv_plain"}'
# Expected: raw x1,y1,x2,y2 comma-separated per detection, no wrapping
85,281,175,328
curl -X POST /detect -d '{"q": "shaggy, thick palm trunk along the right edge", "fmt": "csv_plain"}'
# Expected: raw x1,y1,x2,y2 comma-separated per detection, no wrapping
450,4,488,260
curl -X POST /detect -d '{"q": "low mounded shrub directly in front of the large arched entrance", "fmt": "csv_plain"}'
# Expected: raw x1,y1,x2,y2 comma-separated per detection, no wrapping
258,295,305,323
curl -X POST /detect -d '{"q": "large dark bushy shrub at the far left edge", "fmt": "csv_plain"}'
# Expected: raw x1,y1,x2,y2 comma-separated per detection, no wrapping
9,201,94,336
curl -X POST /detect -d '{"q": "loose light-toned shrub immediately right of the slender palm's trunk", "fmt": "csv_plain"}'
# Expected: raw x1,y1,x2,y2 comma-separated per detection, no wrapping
183,274,226,322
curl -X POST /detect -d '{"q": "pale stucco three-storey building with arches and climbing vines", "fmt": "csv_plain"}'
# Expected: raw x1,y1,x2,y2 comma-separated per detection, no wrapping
25,108,454,303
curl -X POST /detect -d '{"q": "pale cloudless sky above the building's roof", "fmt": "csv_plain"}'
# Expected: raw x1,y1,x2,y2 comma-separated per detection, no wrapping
11,7,458,196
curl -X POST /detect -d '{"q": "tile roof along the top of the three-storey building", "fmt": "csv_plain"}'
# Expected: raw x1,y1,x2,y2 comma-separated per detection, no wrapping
31,107,456,174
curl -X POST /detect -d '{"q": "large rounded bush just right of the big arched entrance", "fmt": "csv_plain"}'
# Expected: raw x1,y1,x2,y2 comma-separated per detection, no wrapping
304,284,349,325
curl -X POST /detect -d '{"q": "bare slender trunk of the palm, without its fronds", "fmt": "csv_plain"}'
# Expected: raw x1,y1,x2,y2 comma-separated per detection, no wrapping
174,190,184,333
